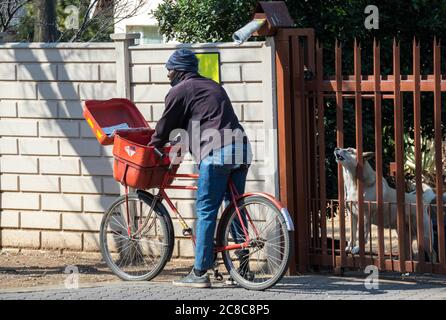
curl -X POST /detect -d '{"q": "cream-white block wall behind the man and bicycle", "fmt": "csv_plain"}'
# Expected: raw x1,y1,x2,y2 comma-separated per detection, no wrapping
0,38,276,256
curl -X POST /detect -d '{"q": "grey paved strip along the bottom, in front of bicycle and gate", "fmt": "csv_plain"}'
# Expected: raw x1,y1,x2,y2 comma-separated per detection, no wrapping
0,274,446,300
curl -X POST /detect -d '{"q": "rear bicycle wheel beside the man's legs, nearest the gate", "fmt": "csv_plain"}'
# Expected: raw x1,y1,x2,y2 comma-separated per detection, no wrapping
217,195,293,290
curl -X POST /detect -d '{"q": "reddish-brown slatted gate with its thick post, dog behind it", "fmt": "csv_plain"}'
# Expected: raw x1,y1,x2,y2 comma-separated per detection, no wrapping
275,28,446,273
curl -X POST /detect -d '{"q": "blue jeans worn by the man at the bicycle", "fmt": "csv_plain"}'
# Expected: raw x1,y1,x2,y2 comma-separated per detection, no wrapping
194,143,252,270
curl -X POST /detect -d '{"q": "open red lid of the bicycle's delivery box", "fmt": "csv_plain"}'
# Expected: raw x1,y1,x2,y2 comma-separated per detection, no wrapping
83,98,150,145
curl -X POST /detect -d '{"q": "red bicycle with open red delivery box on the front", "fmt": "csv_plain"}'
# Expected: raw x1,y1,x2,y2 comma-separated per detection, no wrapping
84,99,294,290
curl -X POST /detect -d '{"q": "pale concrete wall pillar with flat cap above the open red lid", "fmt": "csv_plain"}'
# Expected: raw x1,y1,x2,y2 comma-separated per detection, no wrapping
110,33,140,99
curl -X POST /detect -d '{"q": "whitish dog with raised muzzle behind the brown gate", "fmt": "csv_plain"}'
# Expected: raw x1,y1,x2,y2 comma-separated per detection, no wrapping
334,148,436,259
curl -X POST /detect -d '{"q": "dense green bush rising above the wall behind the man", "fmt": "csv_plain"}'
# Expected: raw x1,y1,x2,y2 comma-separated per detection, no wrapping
153,0,257,42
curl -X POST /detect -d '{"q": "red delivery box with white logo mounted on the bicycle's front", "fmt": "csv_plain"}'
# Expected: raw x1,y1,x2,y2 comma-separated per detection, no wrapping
113,128,179,189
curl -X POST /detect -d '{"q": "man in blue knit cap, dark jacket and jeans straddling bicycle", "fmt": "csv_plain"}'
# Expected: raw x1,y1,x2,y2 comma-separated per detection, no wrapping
150,49,252,288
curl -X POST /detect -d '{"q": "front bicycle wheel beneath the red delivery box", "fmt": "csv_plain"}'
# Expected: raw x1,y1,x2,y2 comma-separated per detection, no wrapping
100,194,174,281
